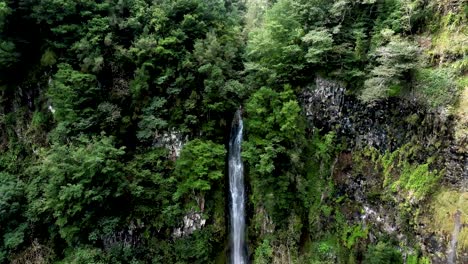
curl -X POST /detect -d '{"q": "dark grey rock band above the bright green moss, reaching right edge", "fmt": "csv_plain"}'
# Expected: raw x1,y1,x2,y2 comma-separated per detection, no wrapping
300,77,468,188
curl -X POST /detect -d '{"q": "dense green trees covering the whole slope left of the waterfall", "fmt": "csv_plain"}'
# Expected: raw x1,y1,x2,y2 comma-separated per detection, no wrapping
0,0,250,263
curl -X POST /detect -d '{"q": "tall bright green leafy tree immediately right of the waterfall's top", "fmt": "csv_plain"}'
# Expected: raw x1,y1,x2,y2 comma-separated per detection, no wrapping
242,86,305,222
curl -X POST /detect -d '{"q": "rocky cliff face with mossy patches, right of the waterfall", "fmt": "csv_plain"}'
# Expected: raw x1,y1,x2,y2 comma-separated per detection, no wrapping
301,77,468,263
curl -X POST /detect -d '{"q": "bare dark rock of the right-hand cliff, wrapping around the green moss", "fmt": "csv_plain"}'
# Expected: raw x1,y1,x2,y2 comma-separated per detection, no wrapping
300,77,468,263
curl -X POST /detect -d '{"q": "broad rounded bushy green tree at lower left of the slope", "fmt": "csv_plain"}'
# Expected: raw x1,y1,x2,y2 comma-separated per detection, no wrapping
28,137,127,245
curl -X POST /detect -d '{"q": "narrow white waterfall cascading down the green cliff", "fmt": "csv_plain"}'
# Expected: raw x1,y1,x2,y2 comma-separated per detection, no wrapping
229,110,246,264
